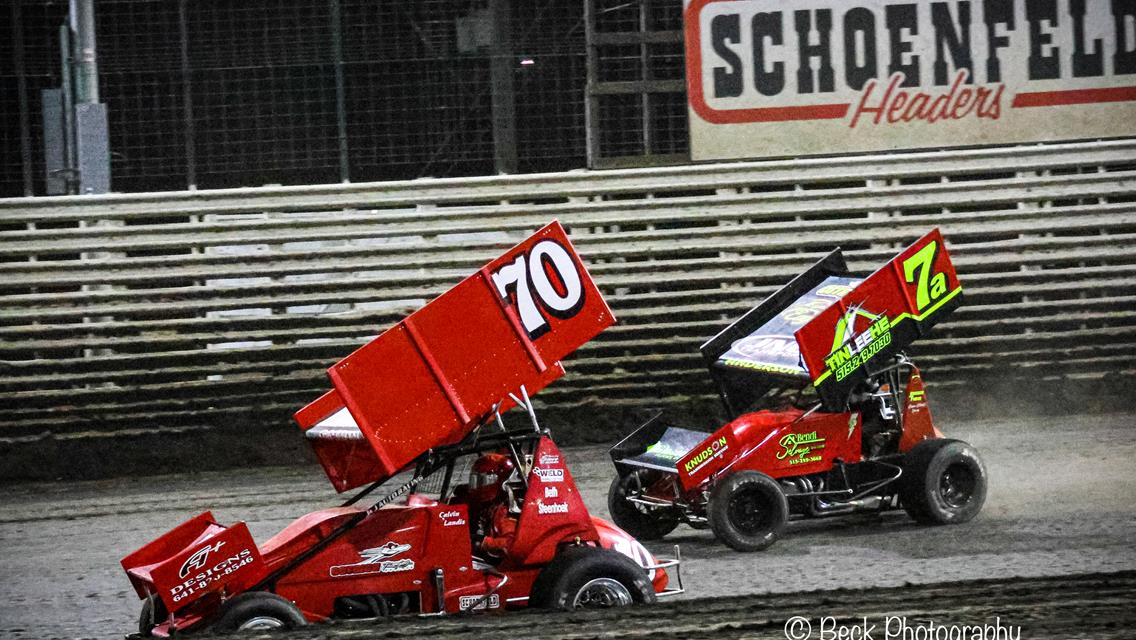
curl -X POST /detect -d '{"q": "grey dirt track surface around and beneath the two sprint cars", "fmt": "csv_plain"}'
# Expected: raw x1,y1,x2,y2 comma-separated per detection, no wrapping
0,414,1136,638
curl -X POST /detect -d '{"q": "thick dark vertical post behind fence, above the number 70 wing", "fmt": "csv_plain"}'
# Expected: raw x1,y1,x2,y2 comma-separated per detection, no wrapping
490,0,517,174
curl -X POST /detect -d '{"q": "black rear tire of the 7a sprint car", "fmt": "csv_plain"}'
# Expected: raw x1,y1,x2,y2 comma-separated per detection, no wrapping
900,439,986,524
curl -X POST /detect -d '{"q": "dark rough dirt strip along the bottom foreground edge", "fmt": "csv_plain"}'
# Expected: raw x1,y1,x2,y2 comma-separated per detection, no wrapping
290,572,1136,640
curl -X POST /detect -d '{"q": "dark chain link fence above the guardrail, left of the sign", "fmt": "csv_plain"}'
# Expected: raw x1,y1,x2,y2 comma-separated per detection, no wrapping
0,0,663,197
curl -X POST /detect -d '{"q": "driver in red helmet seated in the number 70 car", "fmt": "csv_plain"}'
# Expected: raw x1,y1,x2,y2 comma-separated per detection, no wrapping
466,452,520,559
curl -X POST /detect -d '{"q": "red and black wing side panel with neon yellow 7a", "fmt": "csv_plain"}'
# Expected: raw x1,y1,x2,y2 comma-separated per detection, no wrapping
796,228,962,410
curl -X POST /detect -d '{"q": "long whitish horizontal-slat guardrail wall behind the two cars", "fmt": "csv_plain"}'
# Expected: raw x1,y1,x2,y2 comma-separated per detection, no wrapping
0,140,1136,450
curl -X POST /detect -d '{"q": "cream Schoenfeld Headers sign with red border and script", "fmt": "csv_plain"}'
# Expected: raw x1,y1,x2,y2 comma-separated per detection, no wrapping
685,0,1136,160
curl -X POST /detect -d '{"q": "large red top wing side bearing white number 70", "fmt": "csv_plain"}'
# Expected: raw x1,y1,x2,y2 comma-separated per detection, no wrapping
296,222,615,490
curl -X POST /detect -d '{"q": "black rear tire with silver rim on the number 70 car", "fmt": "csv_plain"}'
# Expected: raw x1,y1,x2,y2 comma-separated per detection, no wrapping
528,547,657,610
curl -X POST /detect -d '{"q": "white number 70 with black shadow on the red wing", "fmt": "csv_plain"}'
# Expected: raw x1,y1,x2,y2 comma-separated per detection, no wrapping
492,240,584,340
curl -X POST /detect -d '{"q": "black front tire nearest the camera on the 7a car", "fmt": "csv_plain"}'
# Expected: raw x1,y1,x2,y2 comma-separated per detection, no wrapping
709,471,788,551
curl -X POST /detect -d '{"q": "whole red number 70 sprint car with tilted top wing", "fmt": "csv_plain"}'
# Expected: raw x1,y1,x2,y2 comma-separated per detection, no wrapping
122,222,682,637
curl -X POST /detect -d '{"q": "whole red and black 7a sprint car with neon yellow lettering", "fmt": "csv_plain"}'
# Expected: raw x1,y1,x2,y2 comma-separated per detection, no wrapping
608,230,986,551
